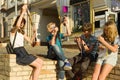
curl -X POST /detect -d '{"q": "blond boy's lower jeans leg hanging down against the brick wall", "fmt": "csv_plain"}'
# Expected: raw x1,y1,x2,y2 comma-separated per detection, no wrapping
58,60,65,79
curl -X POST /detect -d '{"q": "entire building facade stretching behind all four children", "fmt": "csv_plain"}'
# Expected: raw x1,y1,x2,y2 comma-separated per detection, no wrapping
0,0,117,42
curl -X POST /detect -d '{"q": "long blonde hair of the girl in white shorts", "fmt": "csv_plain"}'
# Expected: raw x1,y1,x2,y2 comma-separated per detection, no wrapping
103,21,118,43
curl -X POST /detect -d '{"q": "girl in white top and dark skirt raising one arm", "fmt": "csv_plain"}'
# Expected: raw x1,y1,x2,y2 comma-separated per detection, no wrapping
10,5,43,80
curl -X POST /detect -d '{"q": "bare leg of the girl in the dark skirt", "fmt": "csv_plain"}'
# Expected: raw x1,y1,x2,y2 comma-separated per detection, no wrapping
30,58,43,80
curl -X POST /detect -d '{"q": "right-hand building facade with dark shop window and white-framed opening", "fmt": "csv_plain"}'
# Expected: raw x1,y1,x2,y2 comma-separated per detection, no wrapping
70,0,120,32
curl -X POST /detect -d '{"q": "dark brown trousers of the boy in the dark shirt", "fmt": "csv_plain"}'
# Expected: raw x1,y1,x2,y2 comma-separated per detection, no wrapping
67,53,91,78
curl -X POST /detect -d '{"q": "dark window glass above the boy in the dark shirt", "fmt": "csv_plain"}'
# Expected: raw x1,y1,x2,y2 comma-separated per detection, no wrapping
74,1,90,31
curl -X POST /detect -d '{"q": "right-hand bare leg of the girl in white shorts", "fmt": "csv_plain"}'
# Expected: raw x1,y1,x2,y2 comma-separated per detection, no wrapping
98,64,113,80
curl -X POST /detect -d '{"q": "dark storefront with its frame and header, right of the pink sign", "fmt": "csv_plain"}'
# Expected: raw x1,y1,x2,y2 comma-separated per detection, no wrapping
70,0,90,31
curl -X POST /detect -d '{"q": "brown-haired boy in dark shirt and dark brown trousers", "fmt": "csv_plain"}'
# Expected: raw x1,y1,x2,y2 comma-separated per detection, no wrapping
68,23,98,80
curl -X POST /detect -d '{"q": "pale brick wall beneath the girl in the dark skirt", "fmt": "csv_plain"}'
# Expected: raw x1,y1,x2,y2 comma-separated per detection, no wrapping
0,54,57,80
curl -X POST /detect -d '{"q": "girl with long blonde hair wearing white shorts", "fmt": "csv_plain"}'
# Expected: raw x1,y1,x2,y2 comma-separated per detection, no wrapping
92,21,119,80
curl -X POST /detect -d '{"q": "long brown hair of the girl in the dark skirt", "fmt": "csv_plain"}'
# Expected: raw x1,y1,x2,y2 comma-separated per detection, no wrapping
11,16,26,34
